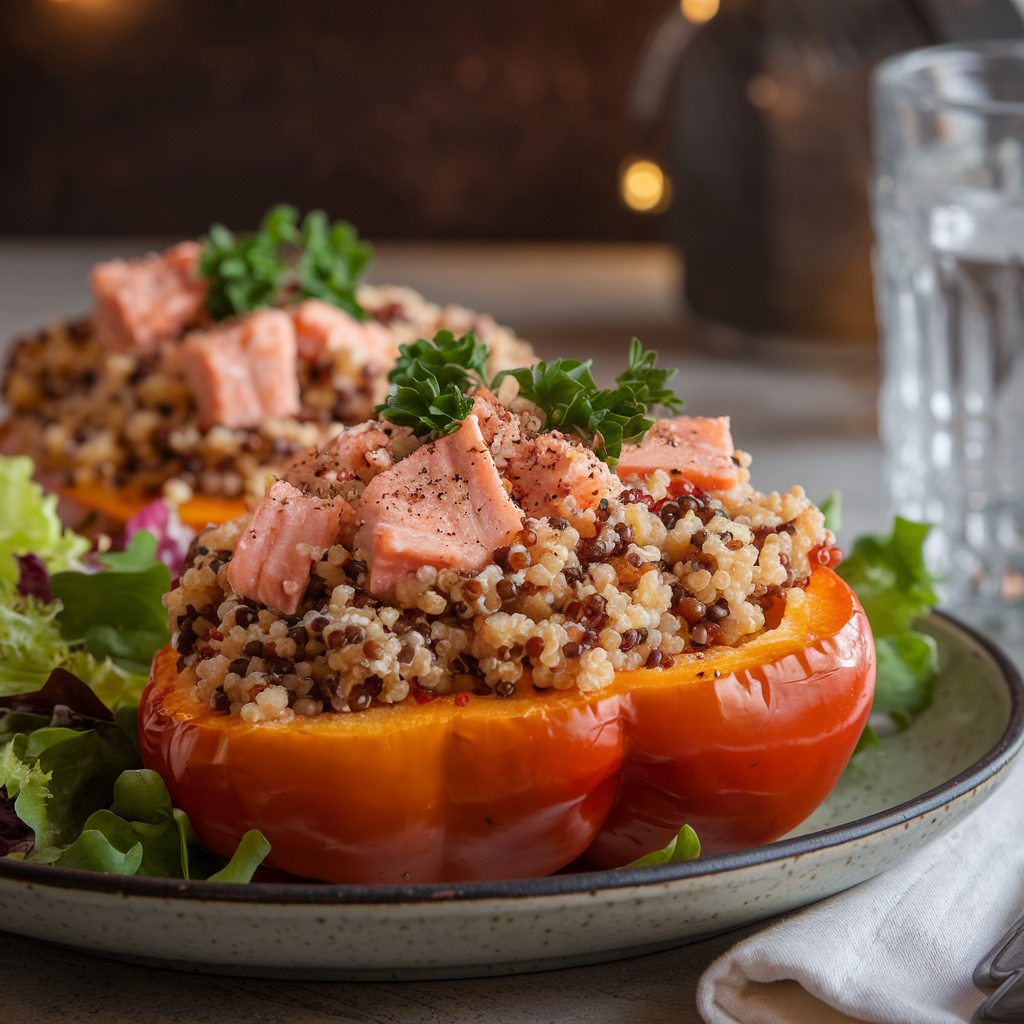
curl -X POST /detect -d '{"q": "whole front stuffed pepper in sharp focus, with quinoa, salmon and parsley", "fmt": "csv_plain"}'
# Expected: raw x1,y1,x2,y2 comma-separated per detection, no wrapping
139,335,874,884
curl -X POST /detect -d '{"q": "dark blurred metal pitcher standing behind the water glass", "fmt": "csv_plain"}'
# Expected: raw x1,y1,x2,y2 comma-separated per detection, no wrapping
633,0,1024,340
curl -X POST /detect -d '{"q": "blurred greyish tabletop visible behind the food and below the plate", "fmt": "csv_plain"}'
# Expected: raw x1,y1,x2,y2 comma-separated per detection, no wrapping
0,239,887,1024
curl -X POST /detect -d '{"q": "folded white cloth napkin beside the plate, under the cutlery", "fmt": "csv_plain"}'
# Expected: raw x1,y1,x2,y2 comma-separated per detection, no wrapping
697,760,1024,1024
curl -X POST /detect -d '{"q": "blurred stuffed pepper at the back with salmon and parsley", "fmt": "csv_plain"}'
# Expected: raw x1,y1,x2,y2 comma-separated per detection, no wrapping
0,207,532,534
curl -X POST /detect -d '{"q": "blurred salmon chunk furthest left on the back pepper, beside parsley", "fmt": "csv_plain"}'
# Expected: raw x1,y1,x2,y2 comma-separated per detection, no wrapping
92,242,206,351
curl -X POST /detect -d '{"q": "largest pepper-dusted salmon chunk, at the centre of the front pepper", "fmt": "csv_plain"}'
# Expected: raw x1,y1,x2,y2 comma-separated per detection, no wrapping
355,415,522,597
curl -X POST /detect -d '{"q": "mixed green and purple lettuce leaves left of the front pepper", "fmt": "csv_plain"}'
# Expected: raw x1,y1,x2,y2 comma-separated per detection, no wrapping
0,457,269,882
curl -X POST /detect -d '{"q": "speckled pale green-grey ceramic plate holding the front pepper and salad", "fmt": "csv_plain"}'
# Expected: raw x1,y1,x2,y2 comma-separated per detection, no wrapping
0,614,1024,980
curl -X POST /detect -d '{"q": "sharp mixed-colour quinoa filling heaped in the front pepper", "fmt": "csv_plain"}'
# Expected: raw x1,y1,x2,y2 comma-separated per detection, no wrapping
165,410,835,722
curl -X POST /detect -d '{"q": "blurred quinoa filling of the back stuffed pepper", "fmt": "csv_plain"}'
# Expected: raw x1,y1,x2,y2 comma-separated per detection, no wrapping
0,285,532,503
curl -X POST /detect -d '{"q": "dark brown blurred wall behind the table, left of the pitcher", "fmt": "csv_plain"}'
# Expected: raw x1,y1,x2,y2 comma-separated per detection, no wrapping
0,0,666,240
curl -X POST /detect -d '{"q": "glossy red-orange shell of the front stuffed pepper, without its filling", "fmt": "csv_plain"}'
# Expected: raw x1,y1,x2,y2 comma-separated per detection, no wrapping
139,568,874,884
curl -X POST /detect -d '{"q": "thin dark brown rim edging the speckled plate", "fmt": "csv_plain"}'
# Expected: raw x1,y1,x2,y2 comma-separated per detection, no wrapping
0,610,1024,905
